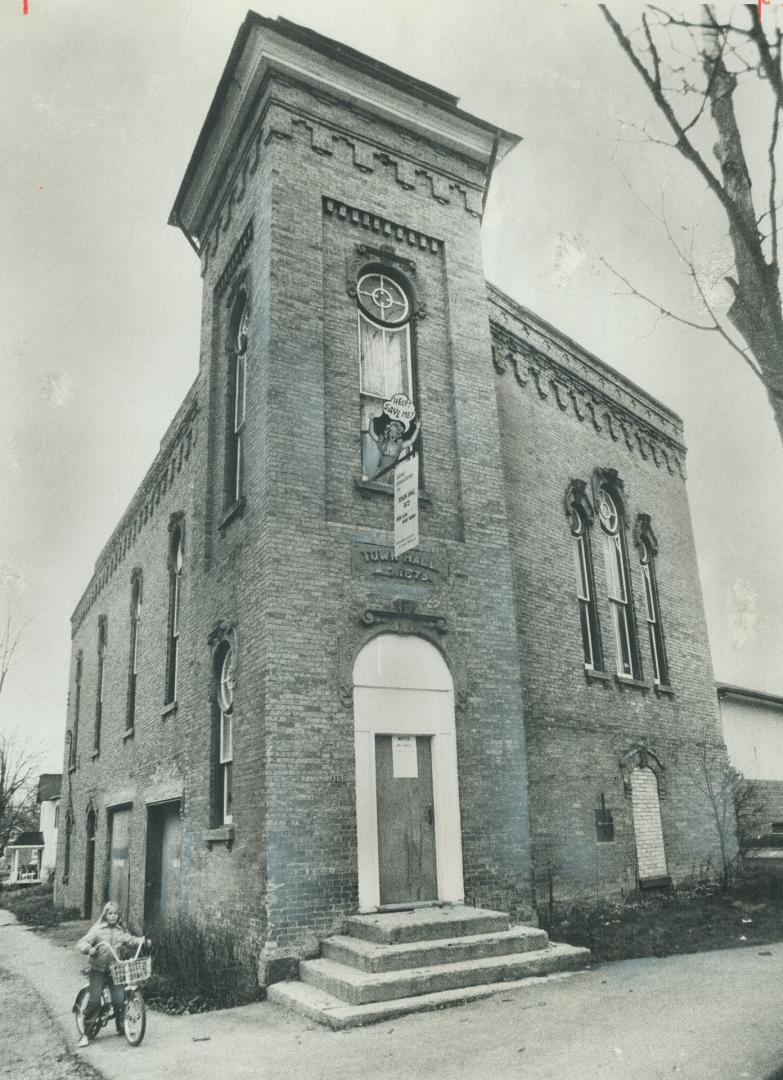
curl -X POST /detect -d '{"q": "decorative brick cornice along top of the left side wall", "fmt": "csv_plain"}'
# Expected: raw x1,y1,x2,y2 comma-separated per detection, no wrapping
70,397,199,637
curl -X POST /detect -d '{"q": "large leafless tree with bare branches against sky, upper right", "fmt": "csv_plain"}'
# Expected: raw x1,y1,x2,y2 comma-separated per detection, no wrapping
600,4,783,440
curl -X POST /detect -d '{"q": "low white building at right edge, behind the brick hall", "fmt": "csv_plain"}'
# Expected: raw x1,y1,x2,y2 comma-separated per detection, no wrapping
717,683,783,846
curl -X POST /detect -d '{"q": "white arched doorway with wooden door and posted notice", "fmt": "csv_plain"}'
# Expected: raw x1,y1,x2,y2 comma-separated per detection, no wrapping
353,634,463,912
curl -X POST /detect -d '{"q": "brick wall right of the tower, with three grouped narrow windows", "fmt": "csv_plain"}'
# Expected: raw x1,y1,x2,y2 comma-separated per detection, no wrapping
490,291,726,900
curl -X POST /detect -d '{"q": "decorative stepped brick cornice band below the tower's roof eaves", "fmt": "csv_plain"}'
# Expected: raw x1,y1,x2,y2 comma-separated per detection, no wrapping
202,87,483,278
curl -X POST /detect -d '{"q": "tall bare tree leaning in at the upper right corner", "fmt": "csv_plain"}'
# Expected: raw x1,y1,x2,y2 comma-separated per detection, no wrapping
600,4,783,441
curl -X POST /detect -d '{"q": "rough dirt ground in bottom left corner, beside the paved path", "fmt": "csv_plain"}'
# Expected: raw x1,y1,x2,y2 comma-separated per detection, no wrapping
0,968,100,1080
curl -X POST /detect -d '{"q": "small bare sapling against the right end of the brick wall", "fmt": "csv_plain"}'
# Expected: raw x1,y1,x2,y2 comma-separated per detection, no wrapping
685,724,766,892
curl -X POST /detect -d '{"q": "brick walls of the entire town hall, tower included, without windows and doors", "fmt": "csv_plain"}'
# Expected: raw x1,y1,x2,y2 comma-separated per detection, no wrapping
51,19,734,961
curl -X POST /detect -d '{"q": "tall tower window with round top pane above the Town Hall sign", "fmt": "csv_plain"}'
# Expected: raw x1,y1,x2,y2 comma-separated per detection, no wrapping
356,270,418,483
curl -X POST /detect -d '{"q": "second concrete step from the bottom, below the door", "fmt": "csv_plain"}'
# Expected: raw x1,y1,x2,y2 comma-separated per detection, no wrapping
299,945,590,1005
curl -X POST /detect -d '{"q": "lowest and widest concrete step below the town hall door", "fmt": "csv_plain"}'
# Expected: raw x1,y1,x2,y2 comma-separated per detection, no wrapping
267,949,589,1031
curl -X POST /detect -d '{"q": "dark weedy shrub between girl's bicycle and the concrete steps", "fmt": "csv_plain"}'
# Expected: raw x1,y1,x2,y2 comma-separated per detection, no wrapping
145,915,260,1012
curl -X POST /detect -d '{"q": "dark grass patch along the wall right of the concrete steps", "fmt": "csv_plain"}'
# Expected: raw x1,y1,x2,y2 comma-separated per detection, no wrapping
540,885,783,960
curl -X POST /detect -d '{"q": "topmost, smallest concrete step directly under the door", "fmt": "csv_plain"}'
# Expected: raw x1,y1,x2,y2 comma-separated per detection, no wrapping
346,904,510,945
